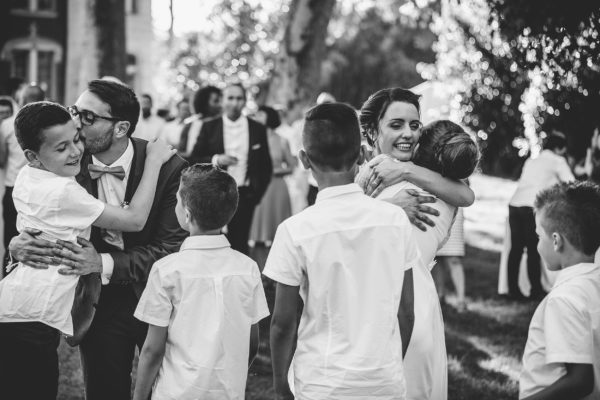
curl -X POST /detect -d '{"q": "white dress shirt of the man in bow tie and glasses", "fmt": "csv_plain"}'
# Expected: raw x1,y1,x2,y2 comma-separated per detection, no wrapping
92,140,134,285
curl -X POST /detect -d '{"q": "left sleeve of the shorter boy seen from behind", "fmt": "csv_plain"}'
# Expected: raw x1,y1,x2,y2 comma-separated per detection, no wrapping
133,264,173,326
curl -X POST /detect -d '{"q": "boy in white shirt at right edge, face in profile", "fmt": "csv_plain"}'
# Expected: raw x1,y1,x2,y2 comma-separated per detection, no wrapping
519,182,600,400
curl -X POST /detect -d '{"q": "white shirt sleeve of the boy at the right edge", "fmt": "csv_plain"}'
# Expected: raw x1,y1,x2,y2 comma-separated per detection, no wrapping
544,297,594,364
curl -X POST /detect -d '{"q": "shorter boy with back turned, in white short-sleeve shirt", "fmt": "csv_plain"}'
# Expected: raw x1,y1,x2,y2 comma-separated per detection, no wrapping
133,164,269,400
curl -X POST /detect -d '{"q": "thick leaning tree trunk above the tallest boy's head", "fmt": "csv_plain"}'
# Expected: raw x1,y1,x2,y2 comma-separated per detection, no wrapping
268,0,335,106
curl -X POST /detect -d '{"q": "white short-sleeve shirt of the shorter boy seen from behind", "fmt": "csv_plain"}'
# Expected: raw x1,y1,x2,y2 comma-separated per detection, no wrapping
134,235,269,400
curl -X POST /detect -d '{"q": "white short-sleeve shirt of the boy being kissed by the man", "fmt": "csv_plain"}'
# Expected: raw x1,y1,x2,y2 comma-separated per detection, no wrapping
0,165,105,335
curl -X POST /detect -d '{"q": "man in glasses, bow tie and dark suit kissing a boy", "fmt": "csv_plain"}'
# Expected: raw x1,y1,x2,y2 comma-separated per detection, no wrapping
9,80,187,400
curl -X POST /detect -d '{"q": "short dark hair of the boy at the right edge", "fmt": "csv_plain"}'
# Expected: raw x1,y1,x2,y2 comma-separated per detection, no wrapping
534,181,600,255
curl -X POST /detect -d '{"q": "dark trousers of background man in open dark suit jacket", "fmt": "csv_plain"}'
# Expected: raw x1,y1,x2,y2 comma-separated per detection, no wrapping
227,186,256,255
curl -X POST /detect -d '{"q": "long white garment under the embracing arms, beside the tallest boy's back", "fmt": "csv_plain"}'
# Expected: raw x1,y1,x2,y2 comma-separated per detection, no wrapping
377,182,456,400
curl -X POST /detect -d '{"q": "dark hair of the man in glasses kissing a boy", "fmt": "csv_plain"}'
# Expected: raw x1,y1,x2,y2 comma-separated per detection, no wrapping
88,79,140,137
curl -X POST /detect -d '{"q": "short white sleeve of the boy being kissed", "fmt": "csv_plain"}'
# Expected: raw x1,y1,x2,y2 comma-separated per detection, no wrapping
53,180,106,230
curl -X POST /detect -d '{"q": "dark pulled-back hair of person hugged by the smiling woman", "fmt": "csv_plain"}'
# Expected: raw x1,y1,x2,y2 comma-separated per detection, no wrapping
412,120,479,179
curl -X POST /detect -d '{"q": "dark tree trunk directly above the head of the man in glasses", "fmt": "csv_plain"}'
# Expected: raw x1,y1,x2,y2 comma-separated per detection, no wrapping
94,0,127,81
